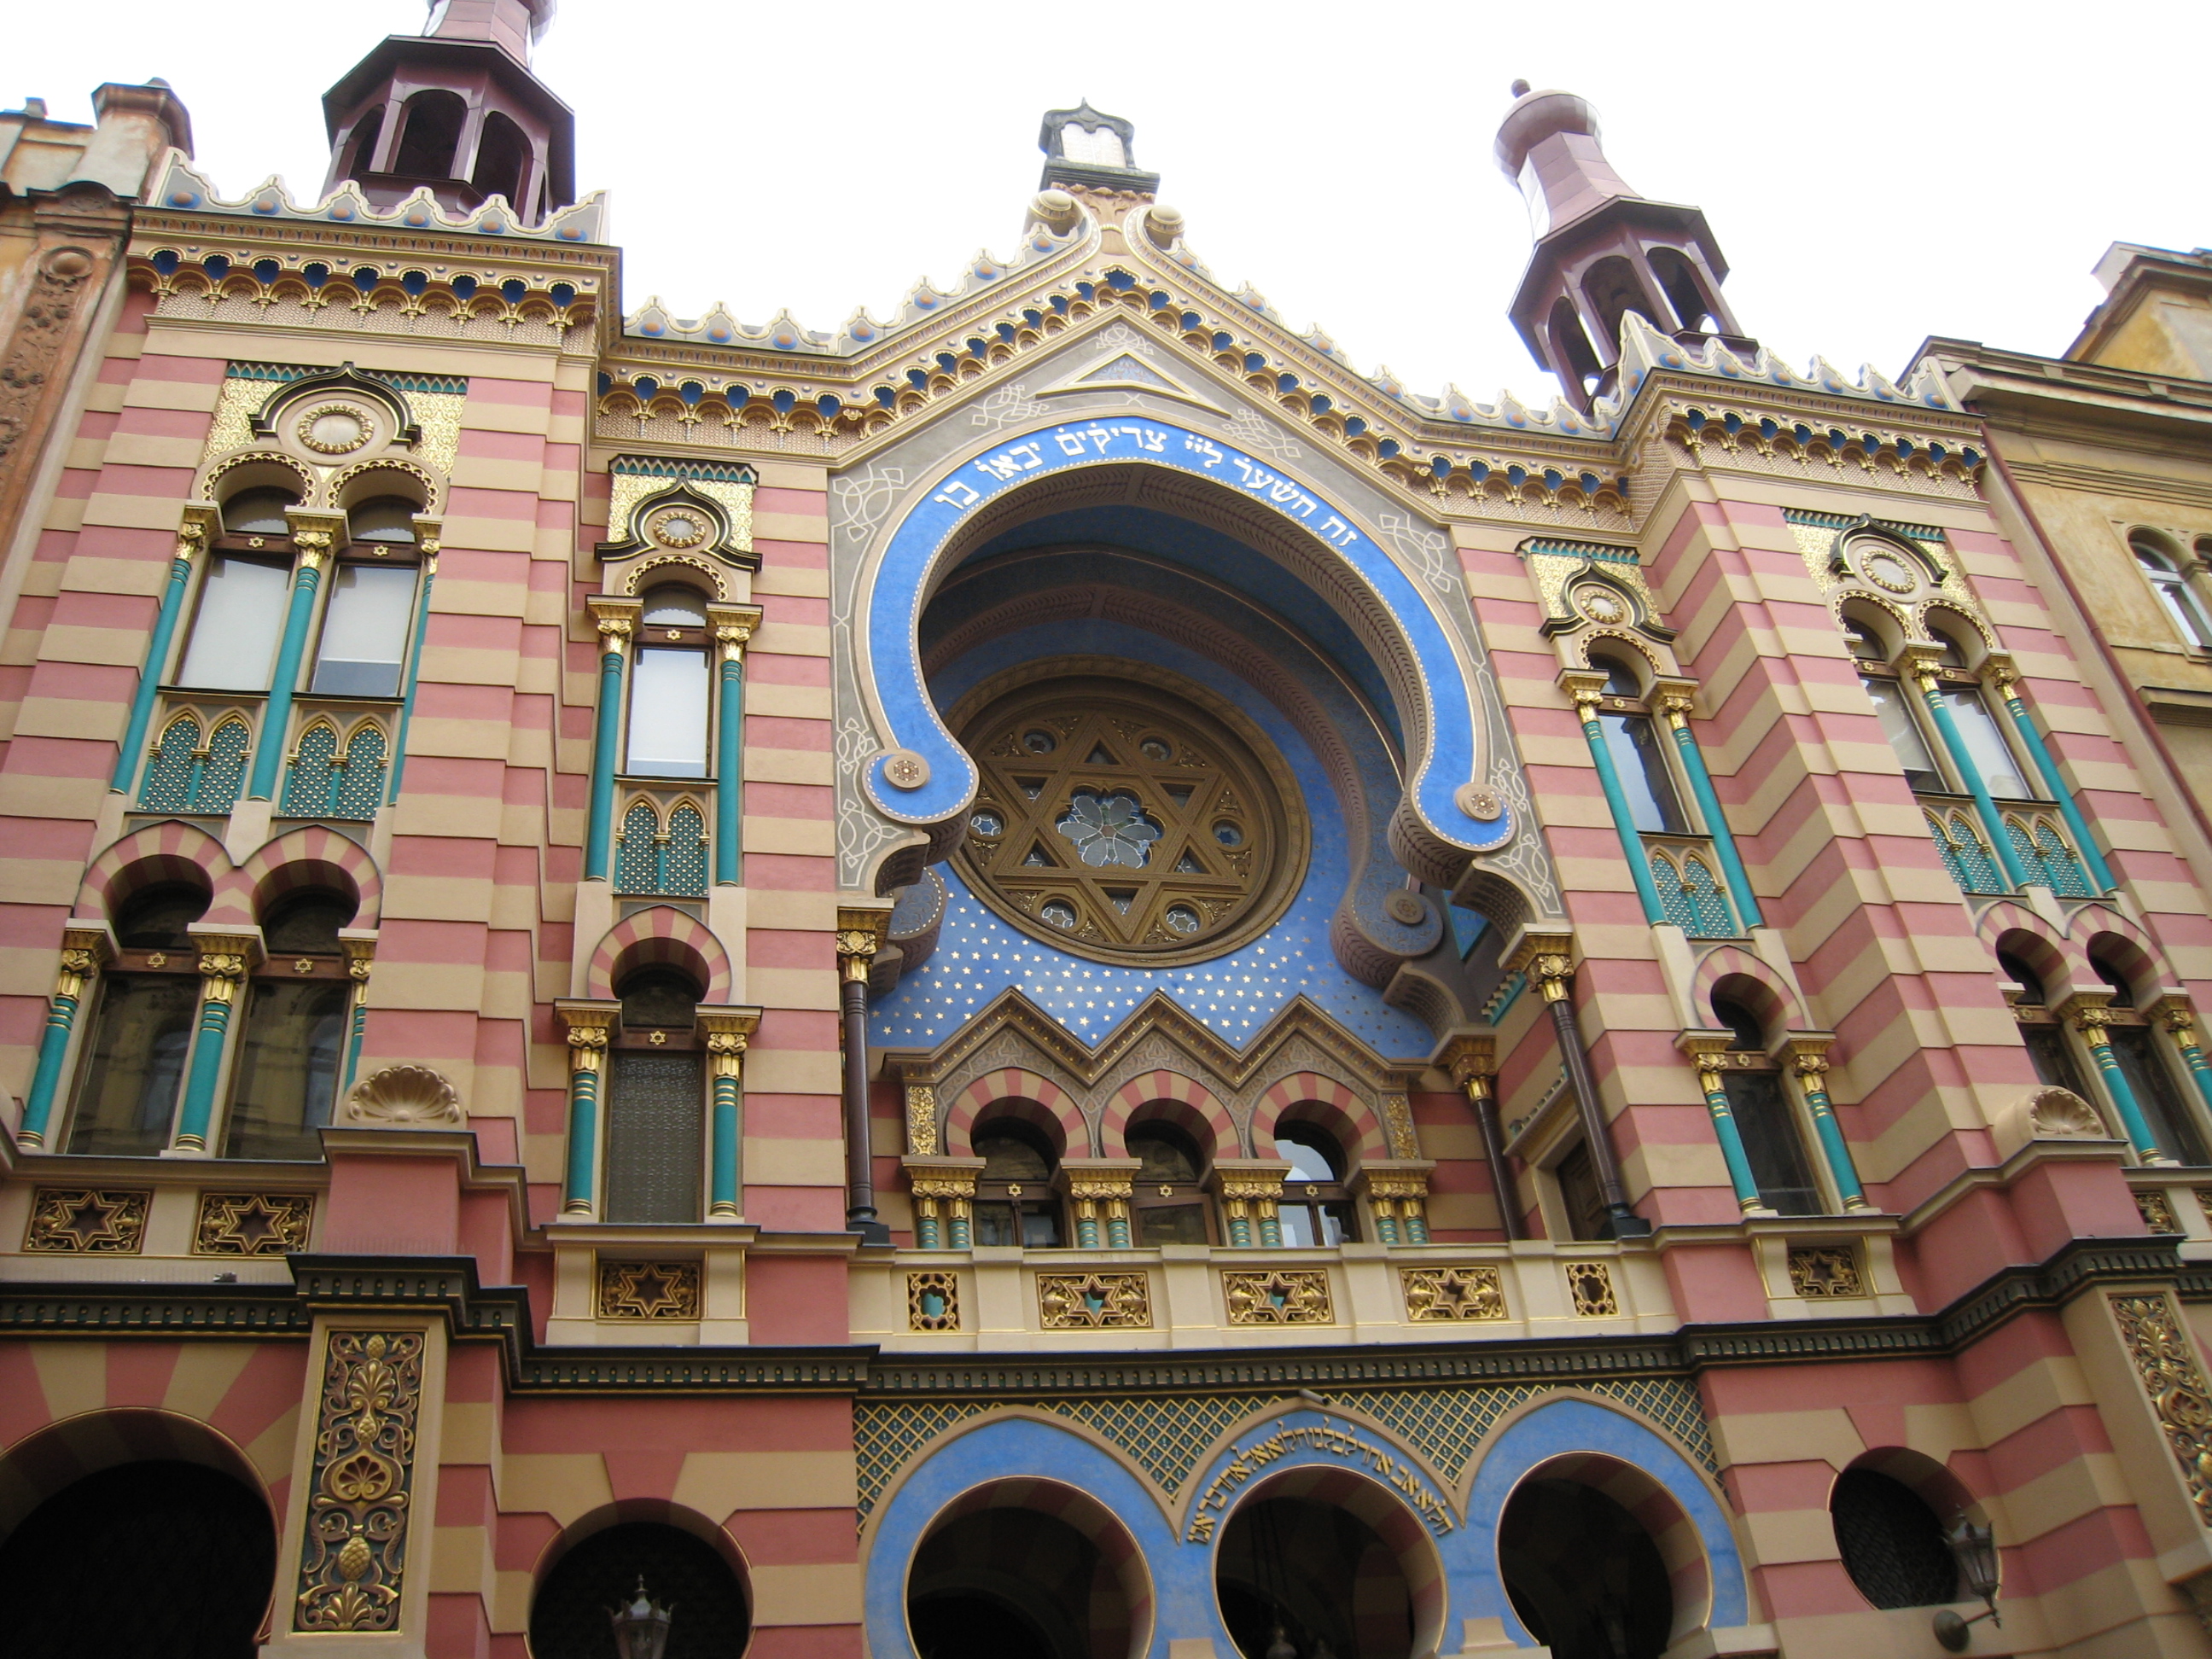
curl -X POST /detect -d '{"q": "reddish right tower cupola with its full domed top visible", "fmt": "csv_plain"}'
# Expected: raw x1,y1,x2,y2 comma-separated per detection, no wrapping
1498,79,1749,410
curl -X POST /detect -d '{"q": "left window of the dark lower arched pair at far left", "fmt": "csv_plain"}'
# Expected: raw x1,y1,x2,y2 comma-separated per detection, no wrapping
68,882,208,1157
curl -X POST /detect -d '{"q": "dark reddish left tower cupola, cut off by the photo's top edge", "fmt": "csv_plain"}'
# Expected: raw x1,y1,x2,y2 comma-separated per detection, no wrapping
323,0,575,225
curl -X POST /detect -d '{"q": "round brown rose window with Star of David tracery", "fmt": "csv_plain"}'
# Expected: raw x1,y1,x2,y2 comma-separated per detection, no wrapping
956,677,1307,967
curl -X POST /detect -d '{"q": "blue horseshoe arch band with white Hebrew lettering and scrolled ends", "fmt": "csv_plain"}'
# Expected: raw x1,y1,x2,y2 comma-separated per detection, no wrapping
854,418,1520,911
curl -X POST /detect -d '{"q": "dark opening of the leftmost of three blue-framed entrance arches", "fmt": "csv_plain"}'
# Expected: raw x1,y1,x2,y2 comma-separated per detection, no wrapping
907,1480,1152,1659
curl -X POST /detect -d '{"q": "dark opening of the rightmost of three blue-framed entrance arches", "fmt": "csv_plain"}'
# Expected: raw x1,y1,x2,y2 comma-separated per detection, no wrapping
1498,1456,1710,1659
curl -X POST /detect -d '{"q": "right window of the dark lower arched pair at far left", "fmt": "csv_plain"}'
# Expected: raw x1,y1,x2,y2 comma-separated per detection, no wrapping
224,887,356,1159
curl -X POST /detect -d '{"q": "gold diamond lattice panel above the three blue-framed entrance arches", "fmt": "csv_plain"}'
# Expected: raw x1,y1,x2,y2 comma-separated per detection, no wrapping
854,1376,1721,1520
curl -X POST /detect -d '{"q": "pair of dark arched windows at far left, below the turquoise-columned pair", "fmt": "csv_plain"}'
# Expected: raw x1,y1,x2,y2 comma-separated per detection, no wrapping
62,881,356,1159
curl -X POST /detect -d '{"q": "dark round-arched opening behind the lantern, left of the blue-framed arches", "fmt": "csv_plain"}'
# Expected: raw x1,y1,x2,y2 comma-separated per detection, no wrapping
531,1522,752,1659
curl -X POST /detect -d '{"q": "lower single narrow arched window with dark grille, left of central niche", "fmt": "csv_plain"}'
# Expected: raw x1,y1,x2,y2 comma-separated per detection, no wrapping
604,967,706,1223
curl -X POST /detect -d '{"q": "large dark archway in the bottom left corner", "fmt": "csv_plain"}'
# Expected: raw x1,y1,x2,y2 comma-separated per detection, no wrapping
0,1458,276,1659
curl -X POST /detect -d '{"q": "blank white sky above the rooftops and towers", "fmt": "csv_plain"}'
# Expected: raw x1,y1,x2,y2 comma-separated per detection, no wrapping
21,0,2212,411
